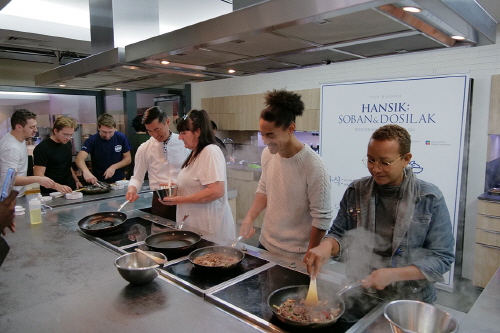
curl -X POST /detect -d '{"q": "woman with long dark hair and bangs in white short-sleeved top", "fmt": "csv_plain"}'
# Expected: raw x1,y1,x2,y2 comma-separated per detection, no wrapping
162,110,236,239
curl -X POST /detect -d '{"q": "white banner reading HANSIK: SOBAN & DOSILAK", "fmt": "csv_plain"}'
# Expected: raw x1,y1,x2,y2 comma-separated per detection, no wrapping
320,75,469,290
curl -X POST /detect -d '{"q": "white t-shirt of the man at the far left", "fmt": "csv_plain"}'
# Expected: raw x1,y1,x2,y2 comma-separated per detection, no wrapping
0,133,28,196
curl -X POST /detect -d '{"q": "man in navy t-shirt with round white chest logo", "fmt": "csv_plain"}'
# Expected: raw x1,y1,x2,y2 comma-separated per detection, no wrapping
75,113,132,184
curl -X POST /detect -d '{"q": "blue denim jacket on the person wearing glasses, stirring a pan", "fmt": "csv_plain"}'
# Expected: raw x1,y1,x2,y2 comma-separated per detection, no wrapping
326,168,455,302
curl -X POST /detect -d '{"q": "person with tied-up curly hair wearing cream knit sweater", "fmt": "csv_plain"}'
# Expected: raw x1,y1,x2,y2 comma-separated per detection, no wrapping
240,90,332,260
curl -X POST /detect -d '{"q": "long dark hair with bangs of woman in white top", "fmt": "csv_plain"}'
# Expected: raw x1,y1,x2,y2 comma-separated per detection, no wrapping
177,110,217,168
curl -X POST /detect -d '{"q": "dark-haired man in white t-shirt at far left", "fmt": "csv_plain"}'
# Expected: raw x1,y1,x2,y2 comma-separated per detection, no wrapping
0,109,55,196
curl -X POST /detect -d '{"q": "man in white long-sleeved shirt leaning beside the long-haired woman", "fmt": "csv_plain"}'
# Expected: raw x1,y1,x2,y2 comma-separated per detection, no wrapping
125,106,191,221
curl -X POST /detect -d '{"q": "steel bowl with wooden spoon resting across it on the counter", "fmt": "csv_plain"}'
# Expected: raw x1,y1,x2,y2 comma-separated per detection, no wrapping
115,251,167,285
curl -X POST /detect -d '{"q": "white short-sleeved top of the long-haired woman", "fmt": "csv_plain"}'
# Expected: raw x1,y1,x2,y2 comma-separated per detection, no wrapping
177,145,236,240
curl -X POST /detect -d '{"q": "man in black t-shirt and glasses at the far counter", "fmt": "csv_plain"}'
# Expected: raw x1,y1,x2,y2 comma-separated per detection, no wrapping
33,116,82,194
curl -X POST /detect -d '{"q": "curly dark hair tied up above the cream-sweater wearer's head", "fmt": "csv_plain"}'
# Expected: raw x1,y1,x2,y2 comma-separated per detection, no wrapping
260,89,304,129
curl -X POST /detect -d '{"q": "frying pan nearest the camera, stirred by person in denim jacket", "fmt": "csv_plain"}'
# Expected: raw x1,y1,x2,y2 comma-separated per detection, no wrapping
267,282,361,328
